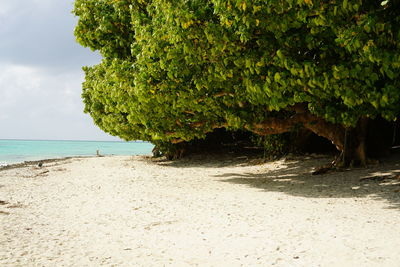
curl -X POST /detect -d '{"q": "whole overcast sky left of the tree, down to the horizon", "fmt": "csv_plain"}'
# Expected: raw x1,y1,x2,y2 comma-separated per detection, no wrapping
0,0,118,140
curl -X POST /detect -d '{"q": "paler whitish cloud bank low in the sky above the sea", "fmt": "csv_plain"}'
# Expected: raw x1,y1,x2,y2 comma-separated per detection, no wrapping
0,62,117,140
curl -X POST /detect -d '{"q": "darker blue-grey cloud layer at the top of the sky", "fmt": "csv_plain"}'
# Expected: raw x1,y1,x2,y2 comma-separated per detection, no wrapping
0,0,100,71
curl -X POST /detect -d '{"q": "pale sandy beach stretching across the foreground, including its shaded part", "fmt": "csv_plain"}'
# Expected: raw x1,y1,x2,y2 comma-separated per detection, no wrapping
0,156,400,266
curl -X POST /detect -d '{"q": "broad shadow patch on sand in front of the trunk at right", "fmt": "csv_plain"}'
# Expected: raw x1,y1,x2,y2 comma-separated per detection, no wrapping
215,154,400,209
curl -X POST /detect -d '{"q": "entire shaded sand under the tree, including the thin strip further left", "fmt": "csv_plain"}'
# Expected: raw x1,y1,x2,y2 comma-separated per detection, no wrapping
147,153,400,209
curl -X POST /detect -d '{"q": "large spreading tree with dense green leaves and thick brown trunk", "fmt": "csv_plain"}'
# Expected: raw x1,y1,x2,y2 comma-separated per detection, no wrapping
73,0,400,164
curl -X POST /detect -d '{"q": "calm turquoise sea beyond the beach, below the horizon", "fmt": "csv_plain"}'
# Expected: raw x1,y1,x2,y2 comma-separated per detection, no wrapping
0,139,154,166
